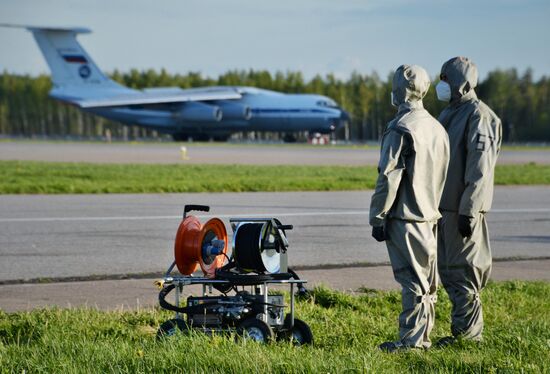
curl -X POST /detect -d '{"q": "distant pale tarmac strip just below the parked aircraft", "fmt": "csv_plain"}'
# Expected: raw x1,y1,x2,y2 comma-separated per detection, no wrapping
0,141,550,165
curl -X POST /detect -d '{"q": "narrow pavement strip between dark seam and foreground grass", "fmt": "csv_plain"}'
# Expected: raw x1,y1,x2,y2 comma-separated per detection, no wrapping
0,260,550,313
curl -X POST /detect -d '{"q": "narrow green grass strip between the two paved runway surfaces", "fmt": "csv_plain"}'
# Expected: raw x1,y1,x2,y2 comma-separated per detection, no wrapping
0,161,550,194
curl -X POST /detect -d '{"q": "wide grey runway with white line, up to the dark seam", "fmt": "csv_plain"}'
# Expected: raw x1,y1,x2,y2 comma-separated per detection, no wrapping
0,186,550,282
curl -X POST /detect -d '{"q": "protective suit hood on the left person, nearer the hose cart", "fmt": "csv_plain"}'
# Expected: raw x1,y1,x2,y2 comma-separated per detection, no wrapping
392,65,430,106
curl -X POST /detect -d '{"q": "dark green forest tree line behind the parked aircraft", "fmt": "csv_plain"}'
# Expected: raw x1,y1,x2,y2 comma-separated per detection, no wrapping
0,69,550,142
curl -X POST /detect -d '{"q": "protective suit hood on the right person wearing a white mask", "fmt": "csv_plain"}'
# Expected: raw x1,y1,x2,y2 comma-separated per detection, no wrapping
441,56,478,102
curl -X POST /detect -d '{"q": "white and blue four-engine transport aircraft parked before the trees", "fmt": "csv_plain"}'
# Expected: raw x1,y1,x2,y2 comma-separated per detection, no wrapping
0,24,349,140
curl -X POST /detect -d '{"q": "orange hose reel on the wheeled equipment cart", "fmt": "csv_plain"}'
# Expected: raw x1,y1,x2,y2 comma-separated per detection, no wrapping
174,216,228,278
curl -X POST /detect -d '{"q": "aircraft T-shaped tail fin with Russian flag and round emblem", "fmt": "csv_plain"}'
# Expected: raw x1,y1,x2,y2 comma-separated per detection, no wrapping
0,24,123,90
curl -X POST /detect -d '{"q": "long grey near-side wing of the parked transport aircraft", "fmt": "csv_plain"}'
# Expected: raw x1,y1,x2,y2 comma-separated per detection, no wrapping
74,87,242,108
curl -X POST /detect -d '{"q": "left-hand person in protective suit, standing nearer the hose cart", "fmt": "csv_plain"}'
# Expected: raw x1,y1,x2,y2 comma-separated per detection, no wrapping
370,65,449,352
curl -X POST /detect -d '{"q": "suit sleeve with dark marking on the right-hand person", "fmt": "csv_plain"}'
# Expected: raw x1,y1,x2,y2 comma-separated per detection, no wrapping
459,111,502,217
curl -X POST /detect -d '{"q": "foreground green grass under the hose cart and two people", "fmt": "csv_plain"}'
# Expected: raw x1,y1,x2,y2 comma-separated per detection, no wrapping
0,282,550,373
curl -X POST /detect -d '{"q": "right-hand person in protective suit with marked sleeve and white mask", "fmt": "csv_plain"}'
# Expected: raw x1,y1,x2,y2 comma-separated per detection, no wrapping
436,57,502,346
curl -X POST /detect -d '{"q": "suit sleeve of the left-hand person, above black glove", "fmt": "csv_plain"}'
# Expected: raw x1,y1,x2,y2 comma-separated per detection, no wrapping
369,129,407,226
